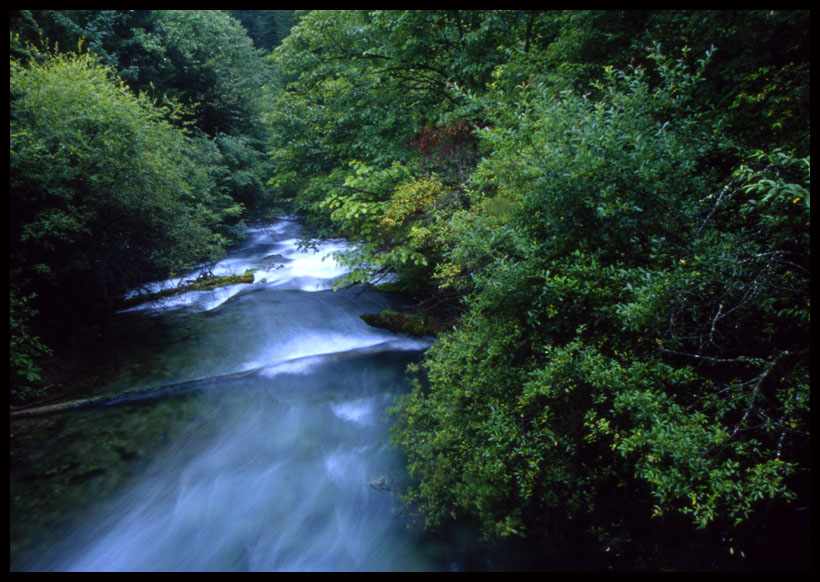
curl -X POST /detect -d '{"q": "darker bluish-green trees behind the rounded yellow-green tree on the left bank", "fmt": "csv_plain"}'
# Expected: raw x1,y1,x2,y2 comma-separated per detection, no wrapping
11,10,272,217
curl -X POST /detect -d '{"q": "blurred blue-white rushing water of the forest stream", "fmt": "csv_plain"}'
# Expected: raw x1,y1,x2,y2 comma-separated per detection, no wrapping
10,220,520,571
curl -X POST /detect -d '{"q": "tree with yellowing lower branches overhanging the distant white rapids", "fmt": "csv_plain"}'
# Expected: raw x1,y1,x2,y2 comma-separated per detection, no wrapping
271,11,524,270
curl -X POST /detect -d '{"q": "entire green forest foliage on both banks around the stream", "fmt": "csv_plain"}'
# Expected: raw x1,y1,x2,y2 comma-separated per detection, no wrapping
10,10,811,569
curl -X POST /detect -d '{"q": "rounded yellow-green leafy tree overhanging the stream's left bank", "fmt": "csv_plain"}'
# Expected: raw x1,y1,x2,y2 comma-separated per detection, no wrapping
9,54,242,324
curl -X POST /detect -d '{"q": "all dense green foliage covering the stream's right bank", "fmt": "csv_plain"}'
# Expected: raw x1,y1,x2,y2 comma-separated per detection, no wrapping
264,11,810,568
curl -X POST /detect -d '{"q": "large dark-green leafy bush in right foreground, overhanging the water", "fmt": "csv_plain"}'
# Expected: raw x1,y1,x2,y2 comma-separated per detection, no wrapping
394,53,809,567
